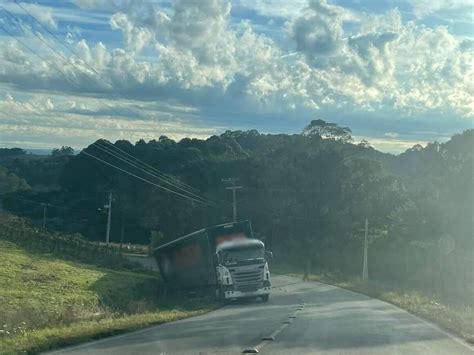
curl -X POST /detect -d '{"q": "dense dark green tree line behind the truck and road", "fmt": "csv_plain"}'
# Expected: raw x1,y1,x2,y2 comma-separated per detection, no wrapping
3,125,474,304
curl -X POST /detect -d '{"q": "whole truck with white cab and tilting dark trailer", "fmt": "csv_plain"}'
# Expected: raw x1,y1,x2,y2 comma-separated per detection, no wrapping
154,220,273,303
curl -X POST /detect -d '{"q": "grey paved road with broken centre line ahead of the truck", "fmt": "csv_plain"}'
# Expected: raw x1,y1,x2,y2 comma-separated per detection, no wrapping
50,276,474,355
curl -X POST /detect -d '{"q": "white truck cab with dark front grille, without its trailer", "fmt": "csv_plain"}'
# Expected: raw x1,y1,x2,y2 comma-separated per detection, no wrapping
216,239,271,302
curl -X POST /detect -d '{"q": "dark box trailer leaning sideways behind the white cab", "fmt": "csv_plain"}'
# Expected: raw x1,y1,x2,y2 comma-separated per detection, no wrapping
154,221,253,289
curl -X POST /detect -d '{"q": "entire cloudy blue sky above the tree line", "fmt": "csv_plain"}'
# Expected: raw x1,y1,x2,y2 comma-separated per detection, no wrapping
0,0,474,153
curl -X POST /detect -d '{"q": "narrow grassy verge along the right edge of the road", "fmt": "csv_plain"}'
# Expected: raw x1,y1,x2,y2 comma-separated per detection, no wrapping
272,265,474,343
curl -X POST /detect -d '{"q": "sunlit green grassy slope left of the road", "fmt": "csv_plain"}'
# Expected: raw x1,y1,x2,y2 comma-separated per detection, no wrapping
0,240,215,354
